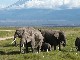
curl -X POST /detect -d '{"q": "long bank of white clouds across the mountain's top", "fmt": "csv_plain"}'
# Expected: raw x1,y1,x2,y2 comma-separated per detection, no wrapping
23,0,80,9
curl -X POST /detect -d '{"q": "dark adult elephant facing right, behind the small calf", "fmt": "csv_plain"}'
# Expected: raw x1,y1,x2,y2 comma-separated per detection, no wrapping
39,29,66,50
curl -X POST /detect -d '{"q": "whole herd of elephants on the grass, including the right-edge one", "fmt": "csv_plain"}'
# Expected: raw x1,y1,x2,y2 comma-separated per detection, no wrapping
12,27,80,53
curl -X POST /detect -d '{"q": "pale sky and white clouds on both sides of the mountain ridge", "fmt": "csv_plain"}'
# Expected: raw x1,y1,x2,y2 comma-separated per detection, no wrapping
0,0,80,9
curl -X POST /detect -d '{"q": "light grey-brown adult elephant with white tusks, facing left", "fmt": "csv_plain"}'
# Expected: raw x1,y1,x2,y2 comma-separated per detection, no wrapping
14,27,43,52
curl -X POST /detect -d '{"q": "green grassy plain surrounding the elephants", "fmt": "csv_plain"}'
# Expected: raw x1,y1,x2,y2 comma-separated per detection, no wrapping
0,27,80,60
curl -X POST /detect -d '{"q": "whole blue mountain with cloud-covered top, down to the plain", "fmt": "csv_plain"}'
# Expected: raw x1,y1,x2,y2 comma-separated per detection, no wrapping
0,0,80,26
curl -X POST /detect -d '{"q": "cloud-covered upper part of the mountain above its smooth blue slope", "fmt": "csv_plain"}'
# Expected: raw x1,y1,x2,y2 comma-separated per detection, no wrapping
6,0,80,9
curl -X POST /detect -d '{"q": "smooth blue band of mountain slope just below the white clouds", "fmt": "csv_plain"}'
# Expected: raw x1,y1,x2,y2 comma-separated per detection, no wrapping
0,9,80,20
